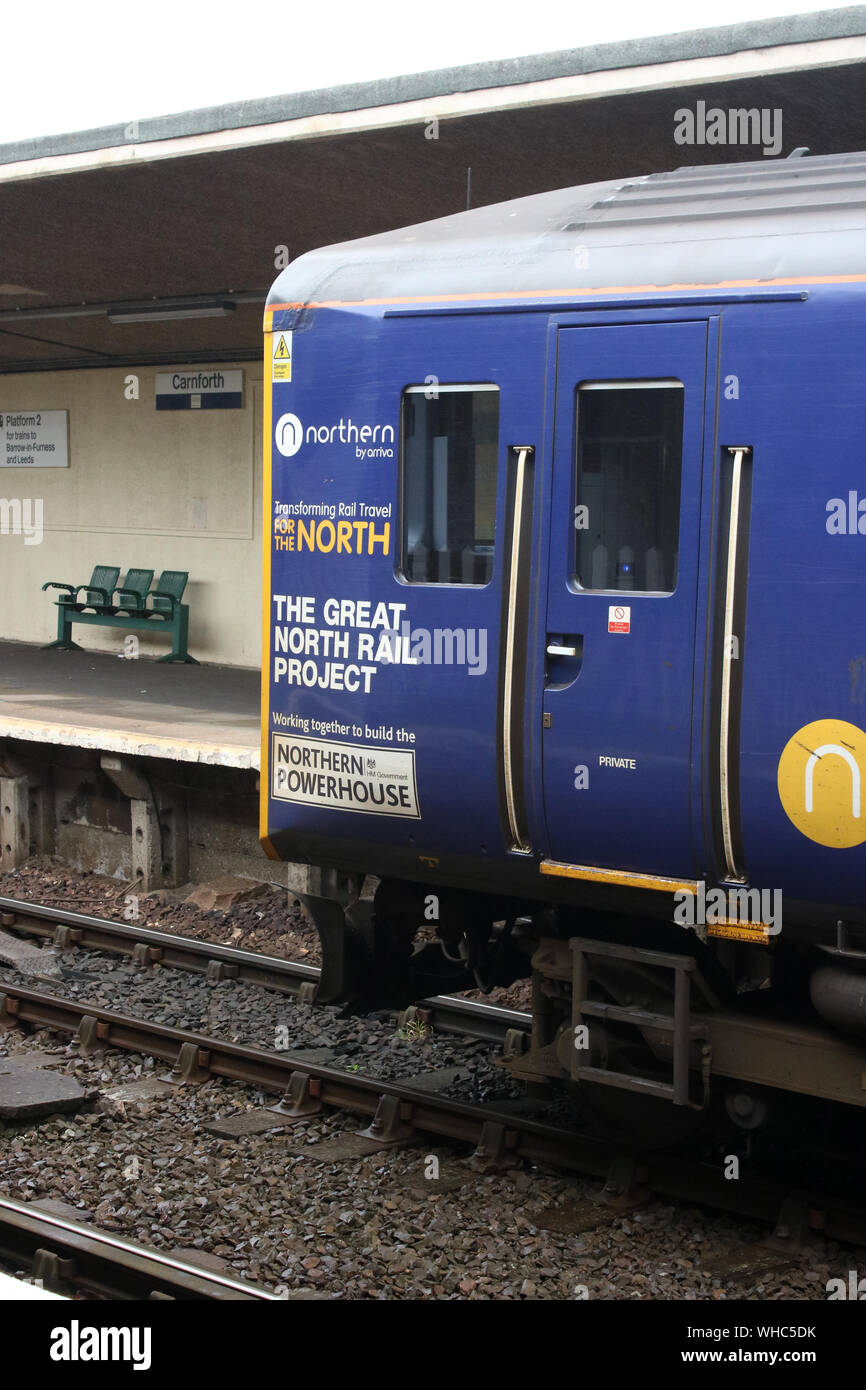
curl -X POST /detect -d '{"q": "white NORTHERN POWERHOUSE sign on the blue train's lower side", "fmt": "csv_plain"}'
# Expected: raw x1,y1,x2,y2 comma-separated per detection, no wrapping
271,734,421,820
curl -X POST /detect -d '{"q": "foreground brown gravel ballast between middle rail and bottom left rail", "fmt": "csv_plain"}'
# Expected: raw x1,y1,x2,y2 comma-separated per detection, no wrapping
0,1030,856,1301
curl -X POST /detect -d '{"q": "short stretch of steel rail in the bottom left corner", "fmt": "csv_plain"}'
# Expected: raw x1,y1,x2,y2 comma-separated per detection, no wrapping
0,1198,278,1302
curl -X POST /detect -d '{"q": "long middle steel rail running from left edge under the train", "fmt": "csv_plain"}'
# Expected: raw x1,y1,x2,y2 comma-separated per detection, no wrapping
0,984,866,1252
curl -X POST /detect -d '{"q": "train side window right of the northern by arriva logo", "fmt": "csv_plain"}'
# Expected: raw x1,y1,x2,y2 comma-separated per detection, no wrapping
400,385,499,584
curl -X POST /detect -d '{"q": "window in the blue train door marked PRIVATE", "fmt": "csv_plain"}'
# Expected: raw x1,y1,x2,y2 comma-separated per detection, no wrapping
573,381,683,594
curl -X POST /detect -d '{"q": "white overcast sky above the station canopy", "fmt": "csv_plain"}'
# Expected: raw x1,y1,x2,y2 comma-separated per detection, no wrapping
0,0,850,143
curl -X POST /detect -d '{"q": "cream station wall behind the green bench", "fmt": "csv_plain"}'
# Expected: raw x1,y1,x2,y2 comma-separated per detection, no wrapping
0,363,261,666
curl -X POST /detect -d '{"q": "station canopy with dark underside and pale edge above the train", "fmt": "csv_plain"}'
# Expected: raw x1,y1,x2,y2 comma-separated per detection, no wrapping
0,6,866,373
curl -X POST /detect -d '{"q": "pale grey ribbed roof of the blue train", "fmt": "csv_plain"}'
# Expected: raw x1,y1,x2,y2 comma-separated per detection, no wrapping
268,153,866,309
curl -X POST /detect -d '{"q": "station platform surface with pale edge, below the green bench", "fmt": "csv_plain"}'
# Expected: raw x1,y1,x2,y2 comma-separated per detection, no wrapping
0,642,260,769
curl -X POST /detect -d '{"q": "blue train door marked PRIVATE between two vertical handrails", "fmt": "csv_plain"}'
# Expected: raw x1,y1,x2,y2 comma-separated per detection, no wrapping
542,321,709,877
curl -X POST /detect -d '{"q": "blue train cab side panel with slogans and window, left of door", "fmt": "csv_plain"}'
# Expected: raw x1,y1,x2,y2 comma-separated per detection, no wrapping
265,310,546,876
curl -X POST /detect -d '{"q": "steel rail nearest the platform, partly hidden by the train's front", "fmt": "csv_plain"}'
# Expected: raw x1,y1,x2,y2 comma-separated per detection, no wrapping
0,897,532,1041
